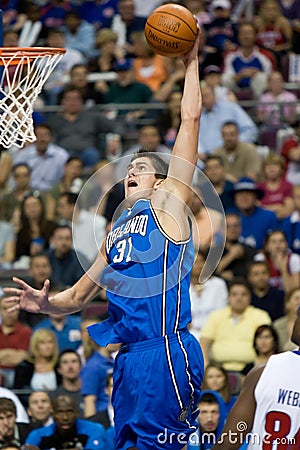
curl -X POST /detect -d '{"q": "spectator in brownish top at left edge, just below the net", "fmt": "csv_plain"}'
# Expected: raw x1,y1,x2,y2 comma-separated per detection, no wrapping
0,163,30,222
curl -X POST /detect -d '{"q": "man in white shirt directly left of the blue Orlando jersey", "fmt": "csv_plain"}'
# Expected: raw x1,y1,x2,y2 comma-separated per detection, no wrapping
57,192,106,269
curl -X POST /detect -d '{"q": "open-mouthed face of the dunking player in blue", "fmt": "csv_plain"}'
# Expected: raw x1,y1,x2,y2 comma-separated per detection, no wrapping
124,157,161,198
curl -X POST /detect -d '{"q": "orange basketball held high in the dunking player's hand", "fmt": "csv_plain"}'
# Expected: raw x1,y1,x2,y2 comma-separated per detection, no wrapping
145,3,198,58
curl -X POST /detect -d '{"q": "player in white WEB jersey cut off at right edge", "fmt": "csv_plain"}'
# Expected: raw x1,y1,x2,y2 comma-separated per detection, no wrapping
213,308,300,450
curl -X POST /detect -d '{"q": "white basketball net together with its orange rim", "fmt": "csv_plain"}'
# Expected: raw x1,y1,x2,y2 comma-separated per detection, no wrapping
0,47,65,148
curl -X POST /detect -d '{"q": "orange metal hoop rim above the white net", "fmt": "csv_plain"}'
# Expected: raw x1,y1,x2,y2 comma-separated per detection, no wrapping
0,47,66,66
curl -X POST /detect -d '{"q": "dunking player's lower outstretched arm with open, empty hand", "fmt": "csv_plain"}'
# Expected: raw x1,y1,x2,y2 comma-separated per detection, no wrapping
4,244,107,315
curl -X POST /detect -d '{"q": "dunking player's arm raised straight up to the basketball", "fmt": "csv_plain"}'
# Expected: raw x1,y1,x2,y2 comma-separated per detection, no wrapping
166,29,202,200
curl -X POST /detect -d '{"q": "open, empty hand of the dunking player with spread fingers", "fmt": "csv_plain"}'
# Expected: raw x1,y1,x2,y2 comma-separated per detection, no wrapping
3,277,50,313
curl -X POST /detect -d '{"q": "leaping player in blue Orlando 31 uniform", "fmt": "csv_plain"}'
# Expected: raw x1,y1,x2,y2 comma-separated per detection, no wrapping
6,28,203,450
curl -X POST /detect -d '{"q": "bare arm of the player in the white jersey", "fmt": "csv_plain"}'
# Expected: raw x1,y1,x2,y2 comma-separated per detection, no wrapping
212,366,265,450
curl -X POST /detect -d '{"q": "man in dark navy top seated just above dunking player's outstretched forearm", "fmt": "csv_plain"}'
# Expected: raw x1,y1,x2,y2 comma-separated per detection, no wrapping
47,224,89,286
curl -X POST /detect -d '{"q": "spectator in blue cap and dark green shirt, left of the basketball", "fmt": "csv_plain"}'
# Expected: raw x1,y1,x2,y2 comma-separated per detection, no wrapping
104,58,153,123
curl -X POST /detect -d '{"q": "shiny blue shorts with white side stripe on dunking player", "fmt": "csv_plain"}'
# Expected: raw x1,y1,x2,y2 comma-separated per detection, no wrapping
112,331,204,450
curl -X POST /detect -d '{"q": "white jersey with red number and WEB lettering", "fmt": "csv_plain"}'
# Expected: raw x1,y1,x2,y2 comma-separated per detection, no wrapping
247,352,300,450
